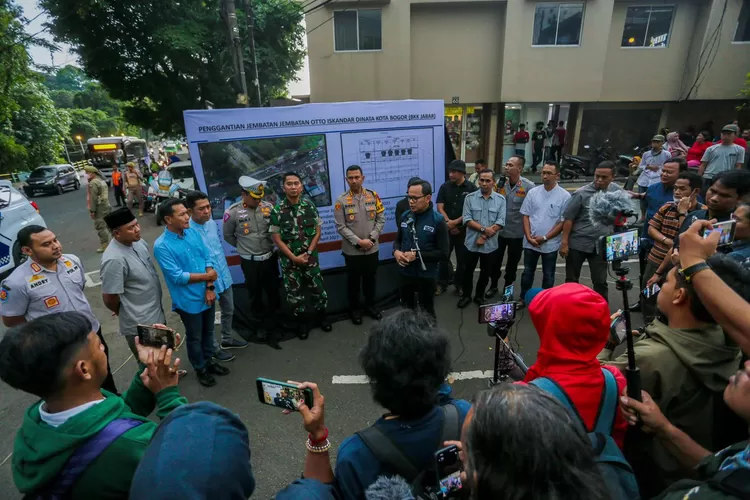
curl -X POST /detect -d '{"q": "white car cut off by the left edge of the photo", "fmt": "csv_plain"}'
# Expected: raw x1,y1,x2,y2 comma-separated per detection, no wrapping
0,181,47,275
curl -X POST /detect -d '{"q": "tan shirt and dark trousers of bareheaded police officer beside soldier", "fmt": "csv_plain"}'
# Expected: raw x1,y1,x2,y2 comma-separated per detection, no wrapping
333,187,385,325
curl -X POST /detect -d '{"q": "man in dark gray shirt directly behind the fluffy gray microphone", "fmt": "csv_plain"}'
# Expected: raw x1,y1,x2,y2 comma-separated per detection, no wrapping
560,161,621,301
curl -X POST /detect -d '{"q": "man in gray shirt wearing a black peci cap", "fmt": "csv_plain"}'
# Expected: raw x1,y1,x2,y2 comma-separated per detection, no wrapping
99,208,166,359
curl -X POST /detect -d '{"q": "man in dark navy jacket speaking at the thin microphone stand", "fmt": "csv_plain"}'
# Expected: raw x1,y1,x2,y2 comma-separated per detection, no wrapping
393,181,448,318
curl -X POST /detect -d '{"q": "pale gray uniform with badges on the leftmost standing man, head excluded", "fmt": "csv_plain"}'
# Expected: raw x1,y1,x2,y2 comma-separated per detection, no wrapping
0,254,117,394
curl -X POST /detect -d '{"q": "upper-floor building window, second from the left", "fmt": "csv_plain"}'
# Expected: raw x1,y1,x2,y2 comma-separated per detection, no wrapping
532,3,583,45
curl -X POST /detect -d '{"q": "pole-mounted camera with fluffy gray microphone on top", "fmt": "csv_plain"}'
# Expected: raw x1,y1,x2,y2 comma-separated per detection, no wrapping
589,190,641,401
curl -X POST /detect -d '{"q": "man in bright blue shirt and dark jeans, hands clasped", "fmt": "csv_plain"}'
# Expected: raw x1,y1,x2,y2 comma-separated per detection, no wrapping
154,199,229,387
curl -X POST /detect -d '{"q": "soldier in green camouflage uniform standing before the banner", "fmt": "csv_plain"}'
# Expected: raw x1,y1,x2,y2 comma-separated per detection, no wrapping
269,173,331,339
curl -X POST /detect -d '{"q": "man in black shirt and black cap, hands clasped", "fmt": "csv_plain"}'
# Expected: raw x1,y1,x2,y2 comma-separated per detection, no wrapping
435,160,477,295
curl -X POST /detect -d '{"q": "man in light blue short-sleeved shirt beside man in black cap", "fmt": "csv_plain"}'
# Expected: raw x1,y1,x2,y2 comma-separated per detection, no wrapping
458,170,505,309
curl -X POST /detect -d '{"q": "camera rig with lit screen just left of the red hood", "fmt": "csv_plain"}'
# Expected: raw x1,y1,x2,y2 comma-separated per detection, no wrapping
478,285,528,387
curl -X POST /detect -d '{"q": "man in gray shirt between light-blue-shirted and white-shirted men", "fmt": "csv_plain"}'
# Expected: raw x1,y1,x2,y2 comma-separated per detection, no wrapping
486,156,534,299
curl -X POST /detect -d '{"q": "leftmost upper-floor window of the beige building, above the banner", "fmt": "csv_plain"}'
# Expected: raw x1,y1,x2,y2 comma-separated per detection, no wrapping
333,9,383,52
